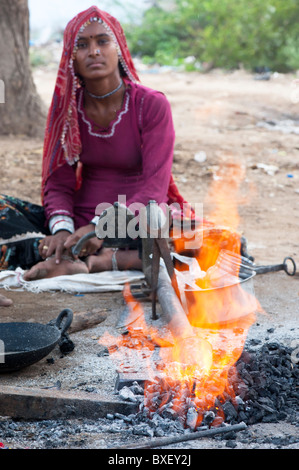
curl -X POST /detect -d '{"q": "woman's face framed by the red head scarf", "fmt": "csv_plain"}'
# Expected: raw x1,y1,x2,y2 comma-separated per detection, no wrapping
74,22,120,80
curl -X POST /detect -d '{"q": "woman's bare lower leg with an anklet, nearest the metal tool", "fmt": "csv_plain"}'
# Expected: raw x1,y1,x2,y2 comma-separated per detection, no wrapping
86,248,142,273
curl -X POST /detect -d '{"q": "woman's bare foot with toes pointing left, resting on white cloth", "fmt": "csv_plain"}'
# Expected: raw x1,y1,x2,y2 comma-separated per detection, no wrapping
24,257,88,281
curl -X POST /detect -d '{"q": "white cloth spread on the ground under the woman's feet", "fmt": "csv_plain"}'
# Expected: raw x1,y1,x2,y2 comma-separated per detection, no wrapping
0,268,144,294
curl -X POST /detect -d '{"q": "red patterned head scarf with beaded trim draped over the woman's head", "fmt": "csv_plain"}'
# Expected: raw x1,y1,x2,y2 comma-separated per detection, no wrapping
42,6,192,215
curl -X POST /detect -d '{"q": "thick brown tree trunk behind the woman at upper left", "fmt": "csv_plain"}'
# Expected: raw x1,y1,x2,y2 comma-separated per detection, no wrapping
0,0,46,137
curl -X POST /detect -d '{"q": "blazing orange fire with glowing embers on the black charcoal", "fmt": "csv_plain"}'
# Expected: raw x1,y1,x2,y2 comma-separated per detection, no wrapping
100,160,259,429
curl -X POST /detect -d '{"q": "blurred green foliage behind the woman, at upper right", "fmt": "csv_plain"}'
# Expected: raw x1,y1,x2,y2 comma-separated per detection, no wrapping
125,0,299,71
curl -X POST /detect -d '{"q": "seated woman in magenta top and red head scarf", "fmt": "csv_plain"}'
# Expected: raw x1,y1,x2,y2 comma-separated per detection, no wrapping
0,6,191,281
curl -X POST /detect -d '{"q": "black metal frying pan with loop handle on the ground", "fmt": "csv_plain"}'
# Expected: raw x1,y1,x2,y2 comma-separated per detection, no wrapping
0,309,73,372
